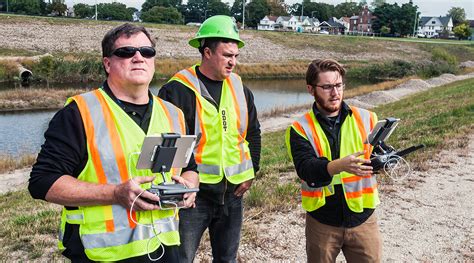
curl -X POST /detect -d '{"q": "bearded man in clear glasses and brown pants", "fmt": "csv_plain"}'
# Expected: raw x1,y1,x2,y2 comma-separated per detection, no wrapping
286,59,382,262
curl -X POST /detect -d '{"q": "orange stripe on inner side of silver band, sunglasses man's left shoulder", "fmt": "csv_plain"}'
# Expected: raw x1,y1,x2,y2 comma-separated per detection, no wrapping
94,89,128,186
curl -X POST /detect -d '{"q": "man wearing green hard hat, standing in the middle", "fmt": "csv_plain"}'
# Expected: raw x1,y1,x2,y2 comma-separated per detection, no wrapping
158,15,261,262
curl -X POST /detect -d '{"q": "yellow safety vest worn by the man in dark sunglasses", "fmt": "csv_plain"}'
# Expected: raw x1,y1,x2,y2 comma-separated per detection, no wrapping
59,89,185,261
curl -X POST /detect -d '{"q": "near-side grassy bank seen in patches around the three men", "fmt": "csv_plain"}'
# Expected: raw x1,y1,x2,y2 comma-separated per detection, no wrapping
0,79,474,260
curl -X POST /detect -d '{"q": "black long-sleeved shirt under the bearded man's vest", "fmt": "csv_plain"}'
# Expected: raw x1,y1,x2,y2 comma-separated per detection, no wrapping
290,102,374,227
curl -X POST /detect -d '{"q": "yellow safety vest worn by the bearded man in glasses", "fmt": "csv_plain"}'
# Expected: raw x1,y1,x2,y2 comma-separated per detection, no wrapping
286,106,380,213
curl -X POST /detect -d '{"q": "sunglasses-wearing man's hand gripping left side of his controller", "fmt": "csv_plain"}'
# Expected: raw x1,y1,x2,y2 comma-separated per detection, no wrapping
114,176,160,211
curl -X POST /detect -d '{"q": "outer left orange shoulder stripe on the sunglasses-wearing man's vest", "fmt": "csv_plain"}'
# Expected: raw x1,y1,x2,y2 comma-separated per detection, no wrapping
74,96,107,184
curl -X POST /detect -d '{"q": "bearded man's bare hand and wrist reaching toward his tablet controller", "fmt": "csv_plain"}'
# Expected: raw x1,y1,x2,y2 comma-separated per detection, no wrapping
328,151,373,176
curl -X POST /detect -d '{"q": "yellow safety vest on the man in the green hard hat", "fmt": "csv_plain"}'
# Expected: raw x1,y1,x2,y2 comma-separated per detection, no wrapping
170,65,254,184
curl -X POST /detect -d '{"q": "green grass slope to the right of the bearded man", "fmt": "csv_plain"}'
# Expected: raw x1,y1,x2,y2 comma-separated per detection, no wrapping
375,79,474,169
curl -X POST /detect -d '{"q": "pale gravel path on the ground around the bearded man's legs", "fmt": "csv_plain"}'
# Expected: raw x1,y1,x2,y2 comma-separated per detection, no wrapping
228,135,474,262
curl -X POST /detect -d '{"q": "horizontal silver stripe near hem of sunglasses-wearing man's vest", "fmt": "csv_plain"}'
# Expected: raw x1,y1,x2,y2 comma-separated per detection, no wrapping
81,217,179,249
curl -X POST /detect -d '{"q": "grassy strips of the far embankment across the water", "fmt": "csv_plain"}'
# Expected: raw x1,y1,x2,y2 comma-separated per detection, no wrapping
0,12,474,82
